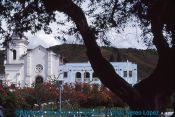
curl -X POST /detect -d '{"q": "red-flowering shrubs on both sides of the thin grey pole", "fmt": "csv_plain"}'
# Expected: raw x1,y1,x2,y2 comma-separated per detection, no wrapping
14,83,125,109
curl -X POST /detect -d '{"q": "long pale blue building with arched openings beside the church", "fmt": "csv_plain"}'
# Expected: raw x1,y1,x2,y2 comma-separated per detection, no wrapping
59,61,137,85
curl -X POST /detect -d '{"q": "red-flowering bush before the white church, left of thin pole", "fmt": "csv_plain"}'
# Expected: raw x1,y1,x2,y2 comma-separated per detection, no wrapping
15,83,58,109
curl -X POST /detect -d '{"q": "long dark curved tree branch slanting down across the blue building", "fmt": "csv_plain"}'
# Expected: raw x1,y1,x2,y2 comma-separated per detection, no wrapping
45,0,140,105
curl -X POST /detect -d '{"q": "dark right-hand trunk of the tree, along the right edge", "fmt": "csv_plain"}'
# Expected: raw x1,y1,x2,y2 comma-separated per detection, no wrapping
132,0,175,114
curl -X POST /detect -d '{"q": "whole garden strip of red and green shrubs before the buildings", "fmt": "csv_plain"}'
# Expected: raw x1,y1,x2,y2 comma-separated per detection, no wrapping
0,82,126,117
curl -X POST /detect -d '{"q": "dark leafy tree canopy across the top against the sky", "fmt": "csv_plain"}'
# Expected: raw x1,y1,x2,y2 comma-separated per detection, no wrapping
0,0,174,48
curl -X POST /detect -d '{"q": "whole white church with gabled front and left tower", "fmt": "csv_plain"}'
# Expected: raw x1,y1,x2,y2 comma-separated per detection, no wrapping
4,33,60,87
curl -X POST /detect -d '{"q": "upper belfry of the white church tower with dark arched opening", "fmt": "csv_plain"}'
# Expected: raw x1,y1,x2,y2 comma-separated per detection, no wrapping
6,32,29,64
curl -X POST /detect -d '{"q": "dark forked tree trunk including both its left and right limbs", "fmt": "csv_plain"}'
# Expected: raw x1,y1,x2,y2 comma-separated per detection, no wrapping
43,0,175,117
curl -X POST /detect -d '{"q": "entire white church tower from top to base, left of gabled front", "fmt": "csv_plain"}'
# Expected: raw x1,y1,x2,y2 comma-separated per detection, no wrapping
4,32,28,87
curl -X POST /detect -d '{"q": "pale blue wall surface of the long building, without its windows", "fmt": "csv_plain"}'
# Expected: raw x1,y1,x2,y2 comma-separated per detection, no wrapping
59,62,137,85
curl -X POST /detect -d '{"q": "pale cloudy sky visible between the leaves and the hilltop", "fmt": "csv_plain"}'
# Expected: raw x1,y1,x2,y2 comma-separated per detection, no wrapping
25,23,147,49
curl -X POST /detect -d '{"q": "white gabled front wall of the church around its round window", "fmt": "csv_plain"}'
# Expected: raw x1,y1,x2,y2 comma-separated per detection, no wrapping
21,46,59,86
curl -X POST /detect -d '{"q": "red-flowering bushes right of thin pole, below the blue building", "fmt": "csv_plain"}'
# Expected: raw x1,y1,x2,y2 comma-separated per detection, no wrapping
63,83,124,108
